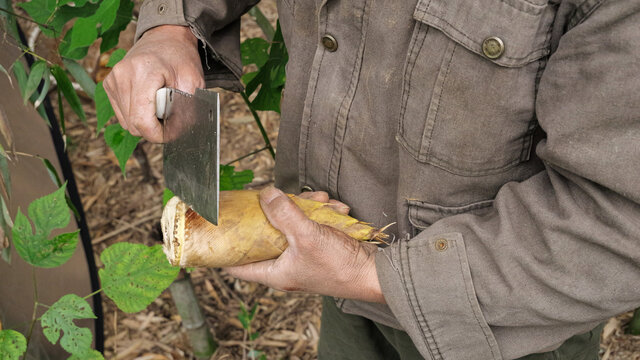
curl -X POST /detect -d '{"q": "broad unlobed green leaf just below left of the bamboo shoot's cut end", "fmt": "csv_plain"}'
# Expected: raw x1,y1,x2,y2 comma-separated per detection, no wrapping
99,243,180,313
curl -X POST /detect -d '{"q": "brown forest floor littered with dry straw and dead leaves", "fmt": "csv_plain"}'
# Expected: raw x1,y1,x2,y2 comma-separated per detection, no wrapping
20,0,640,360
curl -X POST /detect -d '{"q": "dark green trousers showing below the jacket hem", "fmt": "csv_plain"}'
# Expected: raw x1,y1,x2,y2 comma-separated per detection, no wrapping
318,297,603,360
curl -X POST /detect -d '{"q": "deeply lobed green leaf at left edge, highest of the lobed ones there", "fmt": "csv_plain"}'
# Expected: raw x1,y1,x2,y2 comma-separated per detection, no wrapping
12,184,79,268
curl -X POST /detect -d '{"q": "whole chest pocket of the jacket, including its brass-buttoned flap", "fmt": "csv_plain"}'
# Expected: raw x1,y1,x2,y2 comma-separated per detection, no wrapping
396,0,555,176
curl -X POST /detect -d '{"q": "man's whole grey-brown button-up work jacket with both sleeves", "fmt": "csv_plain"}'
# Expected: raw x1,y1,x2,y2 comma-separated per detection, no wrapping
138,0,640,360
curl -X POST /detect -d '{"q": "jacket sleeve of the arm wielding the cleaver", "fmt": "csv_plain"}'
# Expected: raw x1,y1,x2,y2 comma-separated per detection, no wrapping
135,0,259,91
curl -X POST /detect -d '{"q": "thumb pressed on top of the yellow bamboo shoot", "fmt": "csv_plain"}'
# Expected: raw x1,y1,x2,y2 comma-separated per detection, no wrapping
260,187,314,245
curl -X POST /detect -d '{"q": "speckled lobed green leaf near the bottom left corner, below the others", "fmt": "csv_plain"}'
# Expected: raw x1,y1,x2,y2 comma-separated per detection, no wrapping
40,294,96,355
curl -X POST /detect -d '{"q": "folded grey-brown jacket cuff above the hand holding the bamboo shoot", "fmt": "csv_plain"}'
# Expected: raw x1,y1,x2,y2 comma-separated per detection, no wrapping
376,229,502,360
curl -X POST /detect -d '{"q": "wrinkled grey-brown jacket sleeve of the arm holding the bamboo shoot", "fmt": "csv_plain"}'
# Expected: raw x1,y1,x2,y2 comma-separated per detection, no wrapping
376,0,640,360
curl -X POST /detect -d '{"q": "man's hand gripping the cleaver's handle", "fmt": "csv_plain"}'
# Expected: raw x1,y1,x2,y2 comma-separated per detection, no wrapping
103,25,204,143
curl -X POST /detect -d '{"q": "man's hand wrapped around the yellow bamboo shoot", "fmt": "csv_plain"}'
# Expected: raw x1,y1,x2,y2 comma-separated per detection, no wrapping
226,187,385,303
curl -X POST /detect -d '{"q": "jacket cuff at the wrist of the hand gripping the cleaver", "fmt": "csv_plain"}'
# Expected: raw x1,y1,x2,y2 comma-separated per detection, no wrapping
135,0,189,41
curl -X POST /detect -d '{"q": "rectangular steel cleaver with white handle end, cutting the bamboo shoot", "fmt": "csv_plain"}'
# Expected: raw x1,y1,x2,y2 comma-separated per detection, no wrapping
156,88,220,225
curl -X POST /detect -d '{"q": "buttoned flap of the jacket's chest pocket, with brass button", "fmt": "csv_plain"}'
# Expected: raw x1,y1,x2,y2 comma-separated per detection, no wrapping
413,0,555,67
